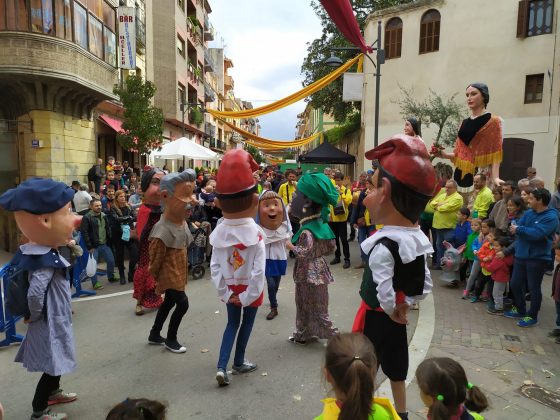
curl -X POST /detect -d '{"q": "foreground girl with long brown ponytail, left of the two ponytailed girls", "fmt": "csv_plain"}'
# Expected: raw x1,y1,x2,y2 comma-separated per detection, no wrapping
315,333,399,420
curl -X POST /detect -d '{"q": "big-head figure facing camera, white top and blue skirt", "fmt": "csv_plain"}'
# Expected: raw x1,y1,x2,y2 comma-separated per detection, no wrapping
257,191,292,320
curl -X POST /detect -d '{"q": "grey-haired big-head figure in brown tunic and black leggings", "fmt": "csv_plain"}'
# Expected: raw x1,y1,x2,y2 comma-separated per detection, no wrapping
148,169,196,353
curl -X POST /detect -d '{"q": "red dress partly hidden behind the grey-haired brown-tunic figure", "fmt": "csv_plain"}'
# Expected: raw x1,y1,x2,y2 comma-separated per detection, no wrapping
132,204,163,308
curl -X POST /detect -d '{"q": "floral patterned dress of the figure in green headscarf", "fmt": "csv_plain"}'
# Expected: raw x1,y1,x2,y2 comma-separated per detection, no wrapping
293,230,338,341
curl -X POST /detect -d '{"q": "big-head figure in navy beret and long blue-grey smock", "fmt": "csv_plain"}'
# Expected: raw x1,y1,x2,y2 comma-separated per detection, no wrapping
0,178,81,419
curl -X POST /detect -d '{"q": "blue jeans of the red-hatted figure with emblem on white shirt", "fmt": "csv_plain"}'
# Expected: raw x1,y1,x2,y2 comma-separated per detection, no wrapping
218,303,258,370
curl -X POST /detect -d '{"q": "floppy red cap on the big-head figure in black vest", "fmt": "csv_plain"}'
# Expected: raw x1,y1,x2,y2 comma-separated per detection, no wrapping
366,134,436,197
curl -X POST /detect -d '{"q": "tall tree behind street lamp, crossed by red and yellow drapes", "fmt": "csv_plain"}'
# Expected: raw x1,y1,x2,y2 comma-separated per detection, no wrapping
301,0,413,123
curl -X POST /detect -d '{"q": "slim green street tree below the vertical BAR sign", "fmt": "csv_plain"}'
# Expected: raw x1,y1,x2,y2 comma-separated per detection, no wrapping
113,75,164,154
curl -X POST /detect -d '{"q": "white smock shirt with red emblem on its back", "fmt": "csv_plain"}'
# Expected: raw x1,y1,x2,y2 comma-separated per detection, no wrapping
210,217,266,306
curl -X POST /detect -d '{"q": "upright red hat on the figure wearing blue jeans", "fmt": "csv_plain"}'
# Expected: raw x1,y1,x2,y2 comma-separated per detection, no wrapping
216,149,259,199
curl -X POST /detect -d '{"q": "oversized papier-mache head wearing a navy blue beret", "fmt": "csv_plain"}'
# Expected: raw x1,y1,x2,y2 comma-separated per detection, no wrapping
0,178,82,248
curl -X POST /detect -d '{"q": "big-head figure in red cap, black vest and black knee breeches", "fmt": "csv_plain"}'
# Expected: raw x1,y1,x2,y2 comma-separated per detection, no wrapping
353,135,436,418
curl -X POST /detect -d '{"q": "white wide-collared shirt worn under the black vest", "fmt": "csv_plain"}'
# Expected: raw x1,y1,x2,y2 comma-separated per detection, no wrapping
361,226,434,315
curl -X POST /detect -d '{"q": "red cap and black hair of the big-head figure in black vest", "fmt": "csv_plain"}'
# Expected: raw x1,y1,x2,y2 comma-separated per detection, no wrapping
366,134,436,223
